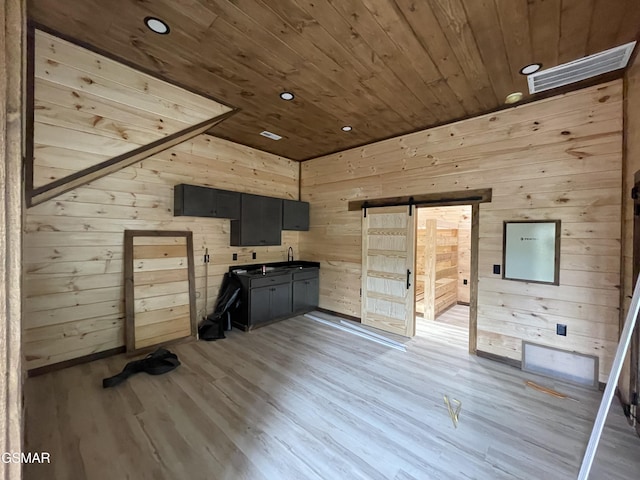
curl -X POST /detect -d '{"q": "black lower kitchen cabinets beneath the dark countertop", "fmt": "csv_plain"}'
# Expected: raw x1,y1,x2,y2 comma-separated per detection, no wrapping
233,267,319,330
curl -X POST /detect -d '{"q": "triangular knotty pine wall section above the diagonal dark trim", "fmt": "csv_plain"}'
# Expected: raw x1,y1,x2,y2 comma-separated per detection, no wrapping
33,30,231,187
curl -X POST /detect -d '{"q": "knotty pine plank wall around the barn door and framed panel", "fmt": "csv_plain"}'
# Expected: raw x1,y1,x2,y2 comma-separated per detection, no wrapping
301,81,622,381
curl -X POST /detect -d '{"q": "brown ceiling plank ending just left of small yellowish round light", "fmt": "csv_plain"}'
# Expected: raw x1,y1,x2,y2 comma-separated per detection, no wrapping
431,0,499,110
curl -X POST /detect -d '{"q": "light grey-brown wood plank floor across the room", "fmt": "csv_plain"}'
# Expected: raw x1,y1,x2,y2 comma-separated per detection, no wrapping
25,317,640,480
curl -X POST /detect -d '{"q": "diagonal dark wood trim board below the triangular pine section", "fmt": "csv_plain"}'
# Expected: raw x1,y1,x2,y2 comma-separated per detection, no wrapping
26,110,238,207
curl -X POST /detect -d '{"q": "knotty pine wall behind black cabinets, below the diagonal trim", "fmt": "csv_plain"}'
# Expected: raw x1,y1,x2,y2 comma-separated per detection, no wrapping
24,135,299,369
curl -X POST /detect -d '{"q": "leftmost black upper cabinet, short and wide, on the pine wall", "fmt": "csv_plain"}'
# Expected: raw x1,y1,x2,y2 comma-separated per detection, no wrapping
173,184,241,218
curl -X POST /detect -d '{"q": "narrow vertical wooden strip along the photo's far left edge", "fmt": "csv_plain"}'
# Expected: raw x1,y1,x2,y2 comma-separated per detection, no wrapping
0,0,26,480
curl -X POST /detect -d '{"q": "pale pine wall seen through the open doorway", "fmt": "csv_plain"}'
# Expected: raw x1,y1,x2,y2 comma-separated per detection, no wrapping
418,205,471,303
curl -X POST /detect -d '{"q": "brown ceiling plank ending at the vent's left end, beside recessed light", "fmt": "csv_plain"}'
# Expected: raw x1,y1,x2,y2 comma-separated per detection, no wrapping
529,0,562,68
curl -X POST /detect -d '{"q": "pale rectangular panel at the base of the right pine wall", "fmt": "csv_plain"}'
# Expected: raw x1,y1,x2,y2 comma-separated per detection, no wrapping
522,342,599,388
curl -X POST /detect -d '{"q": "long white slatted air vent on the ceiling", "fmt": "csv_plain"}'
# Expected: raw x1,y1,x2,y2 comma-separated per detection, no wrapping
527,42,636,93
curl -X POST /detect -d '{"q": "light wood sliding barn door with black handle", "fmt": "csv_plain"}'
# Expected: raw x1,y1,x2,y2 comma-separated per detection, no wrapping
362,206,416,337
